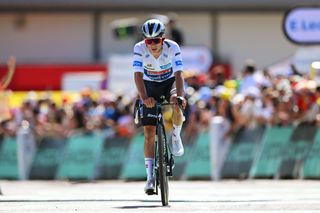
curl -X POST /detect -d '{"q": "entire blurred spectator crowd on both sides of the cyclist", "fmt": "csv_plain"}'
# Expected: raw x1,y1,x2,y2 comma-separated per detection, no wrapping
0,61,320,143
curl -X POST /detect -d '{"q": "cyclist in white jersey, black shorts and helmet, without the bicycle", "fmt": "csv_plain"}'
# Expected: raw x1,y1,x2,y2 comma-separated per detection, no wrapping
133,19,186,194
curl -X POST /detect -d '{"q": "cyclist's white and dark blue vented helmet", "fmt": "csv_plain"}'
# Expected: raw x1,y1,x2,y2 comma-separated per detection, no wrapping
142,19,166,38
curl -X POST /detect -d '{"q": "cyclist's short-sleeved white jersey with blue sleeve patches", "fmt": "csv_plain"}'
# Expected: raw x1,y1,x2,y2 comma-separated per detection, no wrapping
133,39,183,82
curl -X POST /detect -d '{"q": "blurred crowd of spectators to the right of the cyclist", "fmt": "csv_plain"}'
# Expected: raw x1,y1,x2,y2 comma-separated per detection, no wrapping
186,60,320,140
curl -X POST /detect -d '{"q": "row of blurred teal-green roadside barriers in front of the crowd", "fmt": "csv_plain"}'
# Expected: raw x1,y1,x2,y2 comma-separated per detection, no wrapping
0,124,320,180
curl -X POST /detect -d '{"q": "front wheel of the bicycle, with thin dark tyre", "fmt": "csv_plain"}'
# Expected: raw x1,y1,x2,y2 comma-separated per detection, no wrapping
157,125,169,206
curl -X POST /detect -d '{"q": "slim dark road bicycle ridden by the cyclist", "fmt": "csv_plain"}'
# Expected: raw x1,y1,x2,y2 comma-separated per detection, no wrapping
134,100,182,206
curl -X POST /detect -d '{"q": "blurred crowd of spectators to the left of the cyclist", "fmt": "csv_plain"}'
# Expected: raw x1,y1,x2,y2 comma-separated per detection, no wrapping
1,87,135,139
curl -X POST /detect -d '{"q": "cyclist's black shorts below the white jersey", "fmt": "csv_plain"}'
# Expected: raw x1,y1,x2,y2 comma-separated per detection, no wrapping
140,77,177,126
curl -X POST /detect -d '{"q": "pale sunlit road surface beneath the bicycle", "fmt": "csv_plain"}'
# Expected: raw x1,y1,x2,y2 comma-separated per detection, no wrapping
0,180,320,213
